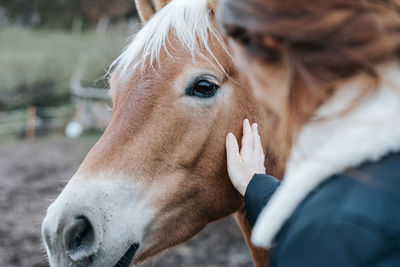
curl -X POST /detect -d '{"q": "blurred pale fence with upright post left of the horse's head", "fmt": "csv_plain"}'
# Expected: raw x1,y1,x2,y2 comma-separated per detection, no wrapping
0,57,111,139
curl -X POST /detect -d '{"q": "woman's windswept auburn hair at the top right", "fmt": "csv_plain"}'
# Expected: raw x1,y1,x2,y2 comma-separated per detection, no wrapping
218,0,400,157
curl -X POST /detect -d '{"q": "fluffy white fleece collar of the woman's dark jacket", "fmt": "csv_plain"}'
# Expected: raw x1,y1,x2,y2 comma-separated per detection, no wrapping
252,63,400,247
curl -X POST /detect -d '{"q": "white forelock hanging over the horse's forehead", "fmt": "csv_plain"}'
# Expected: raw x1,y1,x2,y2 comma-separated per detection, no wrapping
110,0,230,77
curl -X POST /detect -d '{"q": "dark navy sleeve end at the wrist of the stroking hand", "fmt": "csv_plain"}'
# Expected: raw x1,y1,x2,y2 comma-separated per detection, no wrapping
244,174,280,227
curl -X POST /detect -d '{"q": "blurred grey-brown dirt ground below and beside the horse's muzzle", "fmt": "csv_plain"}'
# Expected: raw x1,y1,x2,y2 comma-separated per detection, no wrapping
0,136,252,267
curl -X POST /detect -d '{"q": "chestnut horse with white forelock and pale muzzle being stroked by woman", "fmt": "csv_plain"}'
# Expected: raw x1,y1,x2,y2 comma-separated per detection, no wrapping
42,0,282,266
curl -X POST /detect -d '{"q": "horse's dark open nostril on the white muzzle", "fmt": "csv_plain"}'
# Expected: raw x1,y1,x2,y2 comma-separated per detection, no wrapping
63,216,97,261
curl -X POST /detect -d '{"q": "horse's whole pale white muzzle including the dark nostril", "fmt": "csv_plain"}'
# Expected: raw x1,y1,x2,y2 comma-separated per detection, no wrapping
42,174,154,267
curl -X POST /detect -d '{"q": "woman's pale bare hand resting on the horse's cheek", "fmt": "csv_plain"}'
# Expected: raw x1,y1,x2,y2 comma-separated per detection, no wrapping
226,119,265,196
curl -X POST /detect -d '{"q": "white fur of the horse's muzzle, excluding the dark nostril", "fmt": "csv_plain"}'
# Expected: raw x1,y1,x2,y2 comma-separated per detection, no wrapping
42,172,160,266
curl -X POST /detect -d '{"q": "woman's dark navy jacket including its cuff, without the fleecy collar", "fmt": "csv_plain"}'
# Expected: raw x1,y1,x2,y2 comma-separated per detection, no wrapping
245,153,400,267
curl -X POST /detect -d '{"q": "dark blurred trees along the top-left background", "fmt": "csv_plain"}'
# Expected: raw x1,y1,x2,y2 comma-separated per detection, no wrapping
0,0,136,29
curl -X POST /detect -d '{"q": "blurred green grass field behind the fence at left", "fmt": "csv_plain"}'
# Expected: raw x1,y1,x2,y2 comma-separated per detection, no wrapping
0,27,128,110
